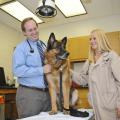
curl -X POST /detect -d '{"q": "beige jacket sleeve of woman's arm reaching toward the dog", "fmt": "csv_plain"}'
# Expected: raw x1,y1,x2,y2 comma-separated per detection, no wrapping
71,60,89,85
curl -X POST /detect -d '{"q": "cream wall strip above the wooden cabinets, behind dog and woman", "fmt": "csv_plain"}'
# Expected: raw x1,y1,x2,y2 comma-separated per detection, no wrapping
40,14,120,40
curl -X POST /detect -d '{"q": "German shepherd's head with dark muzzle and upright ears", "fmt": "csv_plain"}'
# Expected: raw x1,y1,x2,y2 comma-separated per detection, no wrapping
47,33,69,68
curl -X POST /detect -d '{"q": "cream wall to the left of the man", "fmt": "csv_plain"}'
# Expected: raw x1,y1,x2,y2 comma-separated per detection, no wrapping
0,22,20,79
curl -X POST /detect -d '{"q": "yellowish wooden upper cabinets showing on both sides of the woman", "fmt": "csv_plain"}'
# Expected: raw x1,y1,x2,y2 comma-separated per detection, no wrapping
67,31,120,62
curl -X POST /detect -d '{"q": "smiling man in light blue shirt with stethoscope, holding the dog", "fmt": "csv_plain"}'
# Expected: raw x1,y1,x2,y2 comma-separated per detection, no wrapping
13,18,51,118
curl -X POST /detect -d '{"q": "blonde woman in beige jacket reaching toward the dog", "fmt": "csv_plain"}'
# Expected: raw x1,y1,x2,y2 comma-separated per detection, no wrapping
72,29,120,120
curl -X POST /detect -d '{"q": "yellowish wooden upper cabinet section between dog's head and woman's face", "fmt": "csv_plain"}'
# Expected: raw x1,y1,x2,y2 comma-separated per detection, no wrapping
67,36,89,62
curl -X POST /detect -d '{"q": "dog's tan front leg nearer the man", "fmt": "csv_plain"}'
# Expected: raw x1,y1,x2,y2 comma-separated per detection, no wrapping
47,74,57,115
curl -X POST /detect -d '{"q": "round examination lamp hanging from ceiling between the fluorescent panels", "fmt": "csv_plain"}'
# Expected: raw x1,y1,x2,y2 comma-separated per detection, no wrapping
35,0,57,17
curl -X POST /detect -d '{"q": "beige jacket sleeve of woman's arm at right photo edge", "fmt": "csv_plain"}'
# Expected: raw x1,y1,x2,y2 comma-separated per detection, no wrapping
111,52,120,108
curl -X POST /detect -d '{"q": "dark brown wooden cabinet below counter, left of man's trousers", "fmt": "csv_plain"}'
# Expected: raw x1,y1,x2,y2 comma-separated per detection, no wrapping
0,89,18,120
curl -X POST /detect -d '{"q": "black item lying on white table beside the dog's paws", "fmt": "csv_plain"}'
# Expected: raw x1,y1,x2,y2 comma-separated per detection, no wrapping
70,108,89,117
